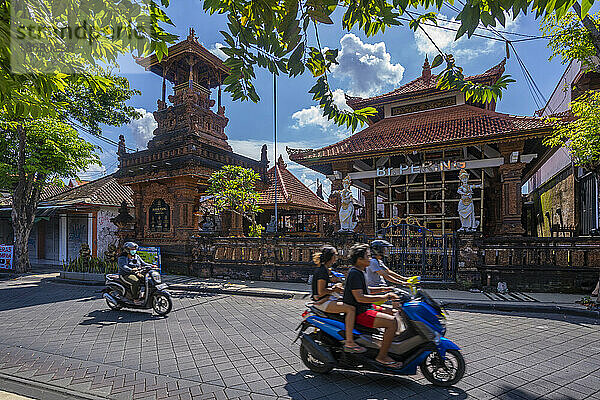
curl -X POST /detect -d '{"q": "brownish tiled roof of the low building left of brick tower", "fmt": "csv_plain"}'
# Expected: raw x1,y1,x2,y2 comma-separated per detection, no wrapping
44,175,133,207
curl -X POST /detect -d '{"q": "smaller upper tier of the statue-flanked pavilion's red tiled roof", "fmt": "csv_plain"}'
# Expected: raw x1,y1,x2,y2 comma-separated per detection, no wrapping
346,60,506,109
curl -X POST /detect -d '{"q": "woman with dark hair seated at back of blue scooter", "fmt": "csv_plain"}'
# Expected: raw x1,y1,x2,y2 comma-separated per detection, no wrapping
312,246,367,353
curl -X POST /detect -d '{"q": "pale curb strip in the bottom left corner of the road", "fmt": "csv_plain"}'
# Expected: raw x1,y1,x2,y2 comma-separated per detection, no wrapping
0,372,108,400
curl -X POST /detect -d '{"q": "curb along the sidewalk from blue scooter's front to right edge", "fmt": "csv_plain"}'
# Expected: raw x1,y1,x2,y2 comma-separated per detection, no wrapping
440,300,600,318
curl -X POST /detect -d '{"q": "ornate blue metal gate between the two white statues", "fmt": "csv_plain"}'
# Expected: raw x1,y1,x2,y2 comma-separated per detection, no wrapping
377,218,458,282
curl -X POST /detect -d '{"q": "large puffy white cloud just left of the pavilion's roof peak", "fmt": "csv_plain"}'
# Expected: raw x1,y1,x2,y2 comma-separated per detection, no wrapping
332,33,404,97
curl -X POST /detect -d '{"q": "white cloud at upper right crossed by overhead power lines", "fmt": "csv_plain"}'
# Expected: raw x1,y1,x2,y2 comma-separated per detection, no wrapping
413,14,518,59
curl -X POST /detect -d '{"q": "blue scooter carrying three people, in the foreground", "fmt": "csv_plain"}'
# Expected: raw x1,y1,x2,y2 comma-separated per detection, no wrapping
294,277,466,387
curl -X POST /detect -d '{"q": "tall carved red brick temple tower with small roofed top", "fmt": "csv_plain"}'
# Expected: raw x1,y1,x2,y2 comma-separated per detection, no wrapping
116,30,268,265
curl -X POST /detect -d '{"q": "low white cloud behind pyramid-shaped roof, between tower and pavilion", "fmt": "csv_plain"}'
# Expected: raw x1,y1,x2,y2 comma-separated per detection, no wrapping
228,139,331,200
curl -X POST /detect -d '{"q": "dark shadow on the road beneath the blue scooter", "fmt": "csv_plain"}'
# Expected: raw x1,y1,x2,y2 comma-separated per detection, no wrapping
285,370,468,400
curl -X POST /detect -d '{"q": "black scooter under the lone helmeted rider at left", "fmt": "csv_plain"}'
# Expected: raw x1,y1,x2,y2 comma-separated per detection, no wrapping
102,267,173,316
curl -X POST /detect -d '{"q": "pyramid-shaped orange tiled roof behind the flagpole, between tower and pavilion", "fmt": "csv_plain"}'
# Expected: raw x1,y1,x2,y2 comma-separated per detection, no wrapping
258,156,335,213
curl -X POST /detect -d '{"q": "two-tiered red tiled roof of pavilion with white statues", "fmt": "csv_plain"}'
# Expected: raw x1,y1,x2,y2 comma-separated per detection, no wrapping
287,61,551,174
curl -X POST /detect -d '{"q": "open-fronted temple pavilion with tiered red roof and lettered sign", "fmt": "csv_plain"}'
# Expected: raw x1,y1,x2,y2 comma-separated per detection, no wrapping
288,59,551,235
